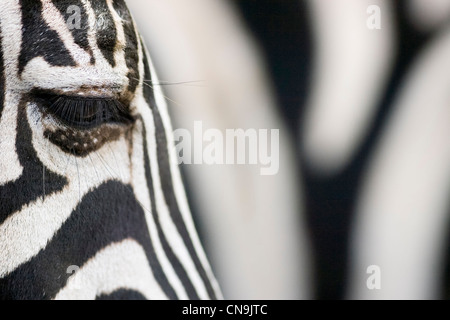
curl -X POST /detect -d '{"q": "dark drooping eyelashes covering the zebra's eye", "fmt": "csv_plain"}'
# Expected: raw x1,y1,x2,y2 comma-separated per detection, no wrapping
34,93,134,130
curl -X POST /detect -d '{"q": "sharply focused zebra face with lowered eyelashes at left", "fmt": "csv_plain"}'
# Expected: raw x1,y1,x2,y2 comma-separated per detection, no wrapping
0,0,222,300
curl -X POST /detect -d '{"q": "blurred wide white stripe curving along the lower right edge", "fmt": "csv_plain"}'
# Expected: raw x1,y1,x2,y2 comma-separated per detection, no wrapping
350,23,450,299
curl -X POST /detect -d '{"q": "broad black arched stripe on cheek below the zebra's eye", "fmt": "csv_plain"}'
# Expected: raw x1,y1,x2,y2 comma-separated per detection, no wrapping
0,181,176,300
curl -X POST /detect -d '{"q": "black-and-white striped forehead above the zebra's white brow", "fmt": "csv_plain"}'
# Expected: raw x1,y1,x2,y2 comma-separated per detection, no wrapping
0,0,139,77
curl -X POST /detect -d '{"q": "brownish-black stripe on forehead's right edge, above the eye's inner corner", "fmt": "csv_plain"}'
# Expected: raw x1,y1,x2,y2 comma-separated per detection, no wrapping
113,0,139,92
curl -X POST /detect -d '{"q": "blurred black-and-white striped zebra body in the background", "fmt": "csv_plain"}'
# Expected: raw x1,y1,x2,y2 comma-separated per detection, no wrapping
133,0,450,299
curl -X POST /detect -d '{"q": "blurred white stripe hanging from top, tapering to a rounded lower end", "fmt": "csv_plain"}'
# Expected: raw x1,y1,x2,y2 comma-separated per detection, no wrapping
302,0,394,173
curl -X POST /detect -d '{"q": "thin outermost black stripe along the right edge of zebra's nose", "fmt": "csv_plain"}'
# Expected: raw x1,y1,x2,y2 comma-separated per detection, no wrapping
143,48,216,299
